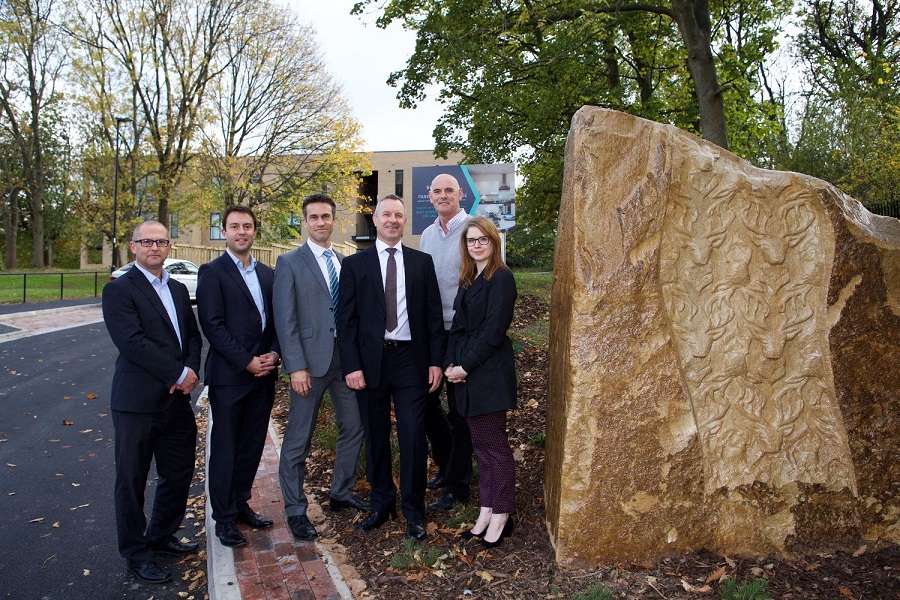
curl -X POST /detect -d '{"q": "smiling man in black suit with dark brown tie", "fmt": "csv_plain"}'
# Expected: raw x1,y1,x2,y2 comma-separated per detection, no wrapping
338,195,445,540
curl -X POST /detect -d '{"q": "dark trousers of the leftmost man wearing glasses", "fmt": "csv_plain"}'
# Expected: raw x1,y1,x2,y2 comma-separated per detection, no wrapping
112,392,197,567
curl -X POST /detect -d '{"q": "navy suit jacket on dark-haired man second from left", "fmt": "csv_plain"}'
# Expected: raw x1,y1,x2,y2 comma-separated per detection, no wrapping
197,252,279,385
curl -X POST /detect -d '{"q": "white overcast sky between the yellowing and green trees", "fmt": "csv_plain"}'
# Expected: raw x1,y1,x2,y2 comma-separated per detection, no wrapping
284,0,441,152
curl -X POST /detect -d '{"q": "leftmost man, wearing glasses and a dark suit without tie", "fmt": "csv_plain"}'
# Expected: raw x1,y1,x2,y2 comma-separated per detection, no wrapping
103,221,203,583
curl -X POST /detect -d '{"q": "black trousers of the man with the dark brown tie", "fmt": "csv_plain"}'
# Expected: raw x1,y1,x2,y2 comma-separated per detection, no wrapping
356,345,428,522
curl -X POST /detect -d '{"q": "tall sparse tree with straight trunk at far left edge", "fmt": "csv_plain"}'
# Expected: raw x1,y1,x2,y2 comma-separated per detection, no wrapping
0,0,66,268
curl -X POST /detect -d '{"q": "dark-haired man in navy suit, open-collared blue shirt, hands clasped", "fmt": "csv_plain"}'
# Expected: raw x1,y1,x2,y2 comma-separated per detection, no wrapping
197,205,281,546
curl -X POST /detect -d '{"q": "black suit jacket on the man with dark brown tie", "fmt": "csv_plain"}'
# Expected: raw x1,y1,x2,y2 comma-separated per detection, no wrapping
338,244,446,387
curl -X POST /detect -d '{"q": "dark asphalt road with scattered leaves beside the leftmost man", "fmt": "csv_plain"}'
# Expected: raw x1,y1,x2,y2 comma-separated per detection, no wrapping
0,316,205,600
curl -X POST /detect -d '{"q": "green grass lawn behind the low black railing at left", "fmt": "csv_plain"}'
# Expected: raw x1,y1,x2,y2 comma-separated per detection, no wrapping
0,271,109,304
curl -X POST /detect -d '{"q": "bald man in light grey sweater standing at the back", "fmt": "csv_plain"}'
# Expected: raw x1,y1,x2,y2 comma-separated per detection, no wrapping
419,174,472,510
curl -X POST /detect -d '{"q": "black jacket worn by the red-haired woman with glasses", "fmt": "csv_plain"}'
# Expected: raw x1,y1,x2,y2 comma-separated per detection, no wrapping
444,269,516,417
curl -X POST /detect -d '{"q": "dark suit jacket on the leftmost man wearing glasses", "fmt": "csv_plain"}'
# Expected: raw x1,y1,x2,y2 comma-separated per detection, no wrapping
103,267,203,413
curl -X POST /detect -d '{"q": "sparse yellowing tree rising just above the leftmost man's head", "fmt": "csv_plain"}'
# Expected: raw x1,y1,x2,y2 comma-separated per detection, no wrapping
73,0,252,229
